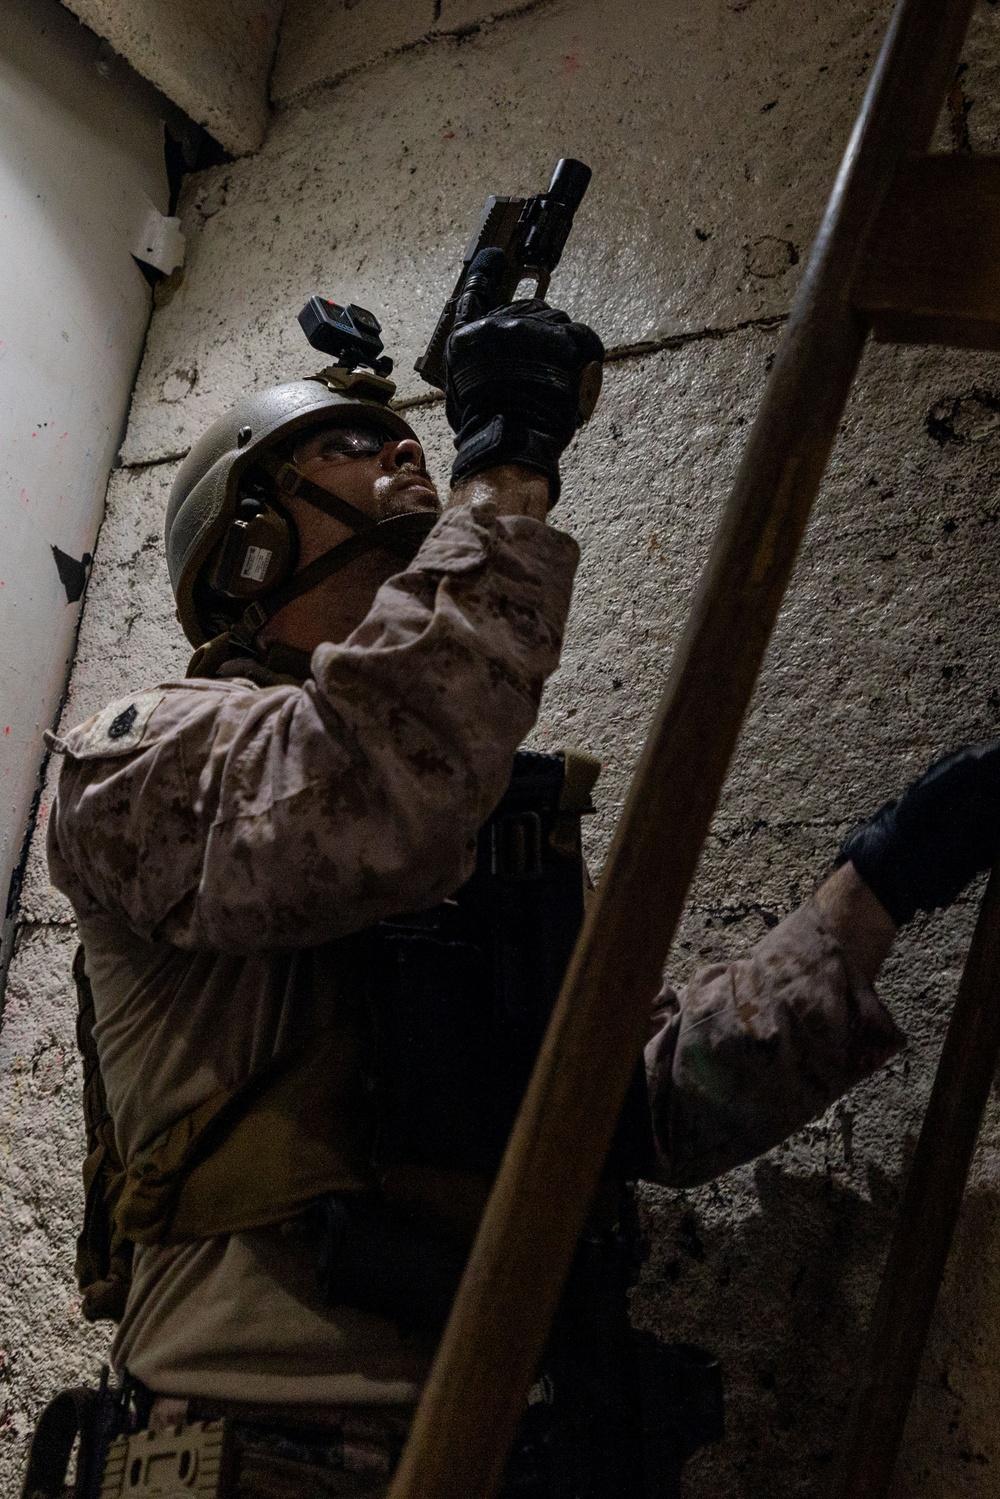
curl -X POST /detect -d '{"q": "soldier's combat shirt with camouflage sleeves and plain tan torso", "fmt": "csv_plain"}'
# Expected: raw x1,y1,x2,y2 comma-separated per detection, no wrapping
49,501,900,1408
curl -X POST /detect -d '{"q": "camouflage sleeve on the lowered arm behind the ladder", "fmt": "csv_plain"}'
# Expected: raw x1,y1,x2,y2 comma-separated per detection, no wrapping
646,901,904,1187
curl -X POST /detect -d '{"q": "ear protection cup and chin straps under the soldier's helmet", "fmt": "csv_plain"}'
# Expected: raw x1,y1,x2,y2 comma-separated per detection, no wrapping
210,454,438,646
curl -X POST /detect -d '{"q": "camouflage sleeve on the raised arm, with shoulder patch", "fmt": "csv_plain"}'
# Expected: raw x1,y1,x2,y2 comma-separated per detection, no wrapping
49,501,579,953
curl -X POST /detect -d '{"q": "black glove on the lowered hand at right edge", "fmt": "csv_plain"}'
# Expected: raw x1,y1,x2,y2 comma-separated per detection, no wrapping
838,739,1000,926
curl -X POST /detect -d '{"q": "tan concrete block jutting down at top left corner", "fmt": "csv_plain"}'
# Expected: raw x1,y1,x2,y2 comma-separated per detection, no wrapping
63,0,282,156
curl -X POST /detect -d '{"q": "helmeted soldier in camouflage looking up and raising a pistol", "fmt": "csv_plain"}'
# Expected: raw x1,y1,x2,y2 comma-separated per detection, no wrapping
35,303,997,1499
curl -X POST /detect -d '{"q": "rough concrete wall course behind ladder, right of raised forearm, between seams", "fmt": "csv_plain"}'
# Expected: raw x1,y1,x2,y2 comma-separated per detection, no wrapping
540,331,1000,848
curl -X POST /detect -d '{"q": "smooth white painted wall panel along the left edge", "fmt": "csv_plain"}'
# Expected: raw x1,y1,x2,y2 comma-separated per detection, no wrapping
0,0,168,965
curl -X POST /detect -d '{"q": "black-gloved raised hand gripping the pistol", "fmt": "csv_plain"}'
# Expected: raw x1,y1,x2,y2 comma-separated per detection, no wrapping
445,250,604,504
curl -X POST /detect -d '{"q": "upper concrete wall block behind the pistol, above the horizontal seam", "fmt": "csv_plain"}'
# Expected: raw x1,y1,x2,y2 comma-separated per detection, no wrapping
123,0,888,463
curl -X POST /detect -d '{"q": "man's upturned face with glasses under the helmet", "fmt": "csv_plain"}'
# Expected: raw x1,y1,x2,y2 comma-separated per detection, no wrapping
295,426,441,520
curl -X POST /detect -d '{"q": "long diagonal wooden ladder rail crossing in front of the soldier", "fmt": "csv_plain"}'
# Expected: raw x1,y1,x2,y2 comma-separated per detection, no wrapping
388,0,973,1499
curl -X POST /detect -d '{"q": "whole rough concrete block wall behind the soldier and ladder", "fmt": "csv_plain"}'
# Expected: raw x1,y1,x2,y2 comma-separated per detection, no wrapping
0,0,1000,1499
